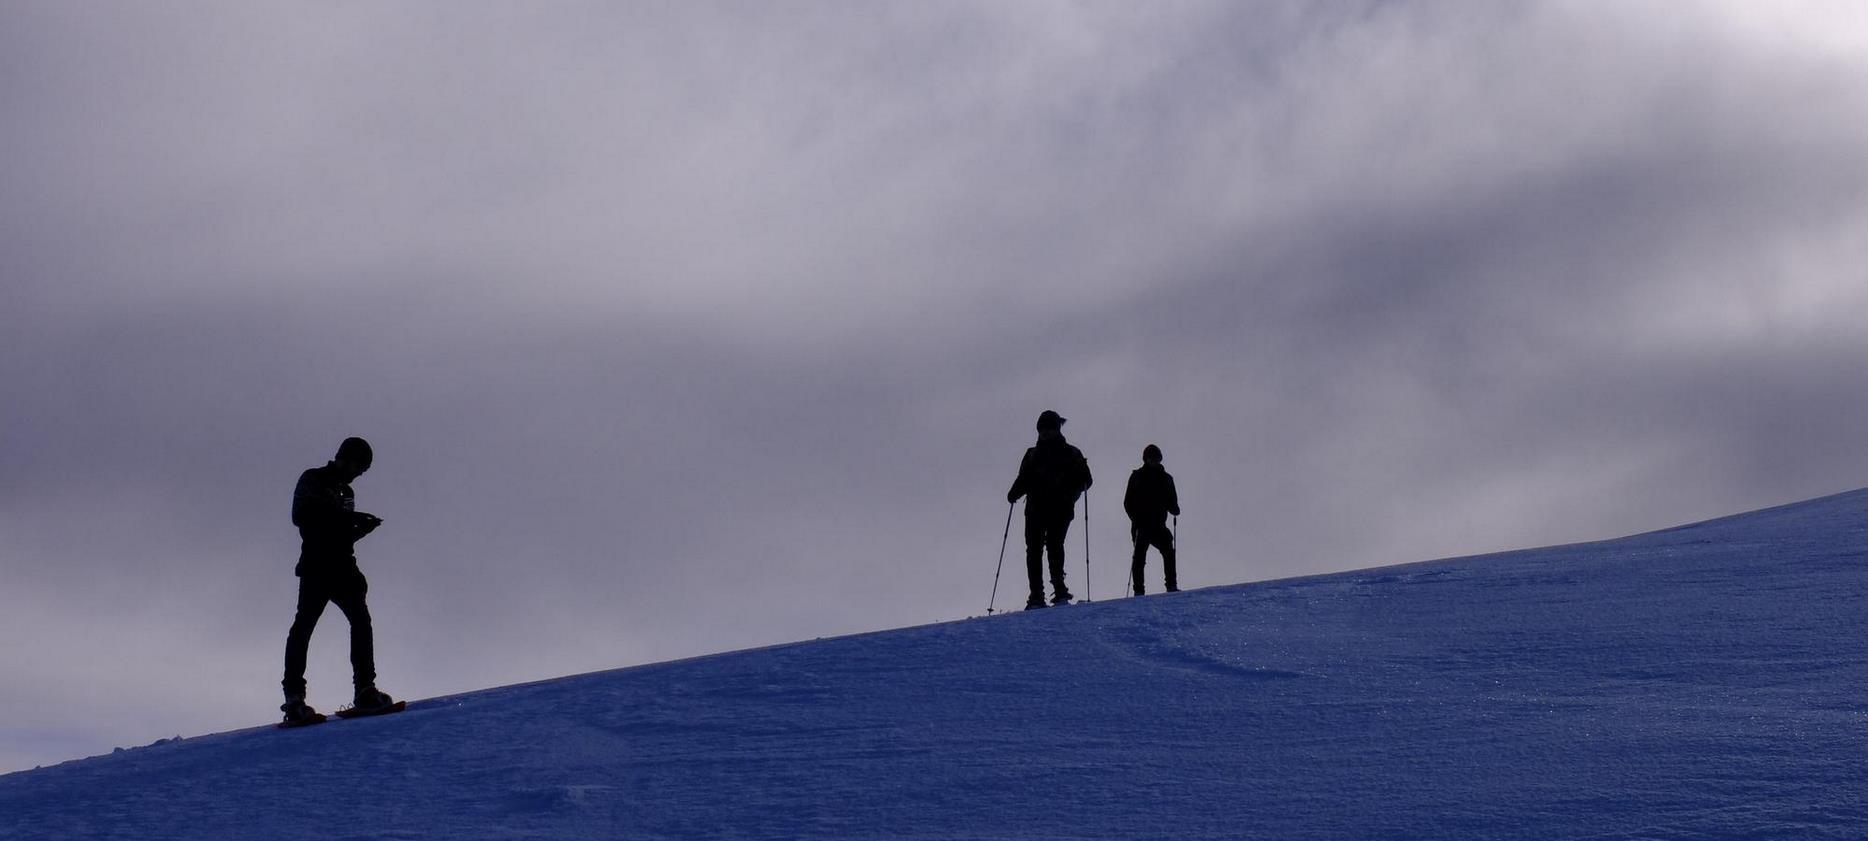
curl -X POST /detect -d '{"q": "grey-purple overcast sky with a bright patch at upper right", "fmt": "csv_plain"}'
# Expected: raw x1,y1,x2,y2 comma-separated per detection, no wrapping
0,0,1868,772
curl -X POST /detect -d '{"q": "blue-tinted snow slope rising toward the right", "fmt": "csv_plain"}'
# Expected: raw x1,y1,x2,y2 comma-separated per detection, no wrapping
0,492,1868,839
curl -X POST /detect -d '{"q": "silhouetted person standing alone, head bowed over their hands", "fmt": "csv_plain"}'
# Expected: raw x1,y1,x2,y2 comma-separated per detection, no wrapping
278,437,392,723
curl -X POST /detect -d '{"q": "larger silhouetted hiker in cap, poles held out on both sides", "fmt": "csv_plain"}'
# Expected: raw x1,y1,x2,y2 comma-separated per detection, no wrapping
1005,409,1091,609
